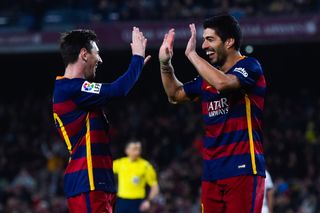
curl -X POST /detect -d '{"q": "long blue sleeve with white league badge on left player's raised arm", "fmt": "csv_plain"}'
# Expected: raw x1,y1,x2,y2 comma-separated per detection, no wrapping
74,55,144,108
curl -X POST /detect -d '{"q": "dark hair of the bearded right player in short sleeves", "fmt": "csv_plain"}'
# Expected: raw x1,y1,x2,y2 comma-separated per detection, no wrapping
203,15,242,50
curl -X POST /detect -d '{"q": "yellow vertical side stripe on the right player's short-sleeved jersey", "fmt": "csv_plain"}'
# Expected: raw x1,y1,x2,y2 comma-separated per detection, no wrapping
244,94,257,175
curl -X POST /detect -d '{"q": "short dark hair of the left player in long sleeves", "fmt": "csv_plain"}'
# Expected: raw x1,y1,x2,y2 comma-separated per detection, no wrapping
60,29,97,66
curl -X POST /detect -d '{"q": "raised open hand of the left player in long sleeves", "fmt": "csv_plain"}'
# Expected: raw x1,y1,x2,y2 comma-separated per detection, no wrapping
131,27,147,57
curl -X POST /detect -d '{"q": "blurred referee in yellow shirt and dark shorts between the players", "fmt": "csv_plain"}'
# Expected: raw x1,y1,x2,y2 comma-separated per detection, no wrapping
113,141,159,213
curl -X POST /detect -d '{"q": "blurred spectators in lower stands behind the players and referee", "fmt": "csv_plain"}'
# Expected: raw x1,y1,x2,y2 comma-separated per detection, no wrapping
0,90,320,213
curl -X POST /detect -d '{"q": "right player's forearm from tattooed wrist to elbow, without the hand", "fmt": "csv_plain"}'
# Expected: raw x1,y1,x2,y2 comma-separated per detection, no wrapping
160,62,183,103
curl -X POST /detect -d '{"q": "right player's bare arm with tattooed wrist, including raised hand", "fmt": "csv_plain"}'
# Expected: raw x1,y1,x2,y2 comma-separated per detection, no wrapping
159,29,190,104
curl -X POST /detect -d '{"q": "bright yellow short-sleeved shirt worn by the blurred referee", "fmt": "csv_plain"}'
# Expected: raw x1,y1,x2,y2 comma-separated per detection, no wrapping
113,157,158,199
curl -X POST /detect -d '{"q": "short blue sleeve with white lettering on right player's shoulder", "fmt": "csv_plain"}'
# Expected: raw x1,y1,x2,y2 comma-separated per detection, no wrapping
228,58,262,89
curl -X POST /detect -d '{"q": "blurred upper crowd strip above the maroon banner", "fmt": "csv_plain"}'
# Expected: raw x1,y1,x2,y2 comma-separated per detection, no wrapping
0,0,320,30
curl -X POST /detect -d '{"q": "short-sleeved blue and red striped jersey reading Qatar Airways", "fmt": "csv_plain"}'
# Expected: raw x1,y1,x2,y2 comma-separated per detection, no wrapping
183,57,266,181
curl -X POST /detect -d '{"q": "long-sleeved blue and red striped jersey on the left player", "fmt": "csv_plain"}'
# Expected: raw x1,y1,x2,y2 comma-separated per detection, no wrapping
53,56,144,197
